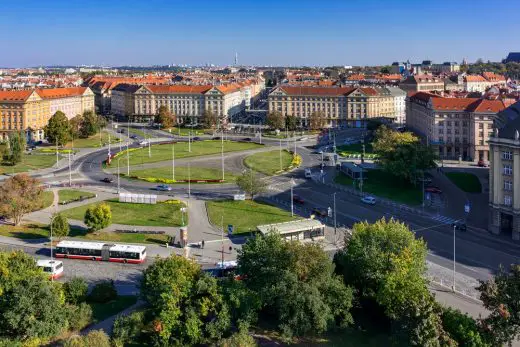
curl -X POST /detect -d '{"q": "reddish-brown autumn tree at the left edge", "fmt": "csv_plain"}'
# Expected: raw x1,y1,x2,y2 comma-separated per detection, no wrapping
0,173,43,225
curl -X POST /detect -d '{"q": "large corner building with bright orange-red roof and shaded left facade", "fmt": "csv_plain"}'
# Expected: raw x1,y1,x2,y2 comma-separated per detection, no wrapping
406,92,505,162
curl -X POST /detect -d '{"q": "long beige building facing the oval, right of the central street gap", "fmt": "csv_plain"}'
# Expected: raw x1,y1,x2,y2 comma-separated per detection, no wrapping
268,86,397,127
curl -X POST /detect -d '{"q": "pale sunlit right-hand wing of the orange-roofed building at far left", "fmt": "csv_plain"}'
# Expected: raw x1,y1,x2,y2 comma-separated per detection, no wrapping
37,87,95,119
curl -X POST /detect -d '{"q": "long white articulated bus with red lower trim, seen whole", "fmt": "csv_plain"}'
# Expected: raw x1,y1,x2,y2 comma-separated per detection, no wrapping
55,241,146,264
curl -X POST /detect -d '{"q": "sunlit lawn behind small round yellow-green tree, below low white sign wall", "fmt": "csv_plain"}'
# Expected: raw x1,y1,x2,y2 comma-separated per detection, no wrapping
63,200,186,227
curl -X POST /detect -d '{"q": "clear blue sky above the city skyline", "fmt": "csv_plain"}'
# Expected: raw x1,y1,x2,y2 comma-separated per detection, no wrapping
0,0,520,67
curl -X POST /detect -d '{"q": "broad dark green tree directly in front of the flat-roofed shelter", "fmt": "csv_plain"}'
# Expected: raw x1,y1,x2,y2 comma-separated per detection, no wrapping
237,232,353,338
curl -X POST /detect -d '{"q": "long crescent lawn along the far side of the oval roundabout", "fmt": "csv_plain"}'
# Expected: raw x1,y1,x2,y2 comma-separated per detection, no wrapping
112,140,262,166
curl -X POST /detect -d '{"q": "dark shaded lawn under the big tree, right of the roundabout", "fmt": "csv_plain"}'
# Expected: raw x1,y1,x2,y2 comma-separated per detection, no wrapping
334,170,422,205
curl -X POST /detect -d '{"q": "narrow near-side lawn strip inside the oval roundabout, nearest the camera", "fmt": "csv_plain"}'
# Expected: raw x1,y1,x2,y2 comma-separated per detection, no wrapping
125,166,236,184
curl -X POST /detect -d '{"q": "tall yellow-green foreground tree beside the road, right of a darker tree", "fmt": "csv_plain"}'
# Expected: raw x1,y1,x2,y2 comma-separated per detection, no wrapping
335,219,450,346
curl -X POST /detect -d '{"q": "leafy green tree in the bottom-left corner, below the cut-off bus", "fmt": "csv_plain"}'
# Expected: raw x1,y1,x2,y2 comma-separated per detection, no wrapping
0,276,67,341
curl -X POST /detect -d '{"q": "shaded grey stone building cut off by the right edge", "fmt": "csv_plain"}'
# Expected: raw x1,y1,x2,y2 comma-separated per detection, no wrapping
488,102,520,240
